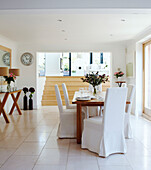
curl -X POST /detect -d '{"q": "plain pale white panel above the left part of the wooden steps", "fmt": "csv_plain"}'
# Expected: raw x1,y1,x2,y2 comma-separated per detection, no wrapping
46,53,61,76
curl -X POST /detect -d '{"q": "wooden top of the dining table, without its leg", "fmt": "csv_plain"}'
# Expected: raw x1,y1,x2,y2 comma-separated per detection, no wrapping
72,91,130,106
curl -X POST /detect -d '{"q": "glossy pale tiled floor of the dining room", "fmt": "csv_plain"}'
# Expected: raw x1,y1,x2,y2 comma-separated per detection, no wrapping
0,107,151,170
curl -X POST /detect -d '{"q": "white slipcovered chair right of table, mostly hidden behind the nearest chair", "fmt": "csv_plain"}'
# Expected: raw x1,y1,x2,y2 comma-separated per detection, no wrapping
124,85,135,139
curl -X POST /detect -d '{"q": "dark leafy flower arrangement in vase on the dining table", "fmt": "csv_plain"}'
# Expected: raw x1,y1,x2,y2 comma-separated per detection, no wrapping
81,71,109,95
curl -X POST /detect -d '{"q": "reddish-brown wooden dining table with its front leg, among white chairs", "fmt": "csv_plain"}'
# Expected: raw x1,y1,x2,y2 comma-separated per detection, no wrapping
72,92,130,144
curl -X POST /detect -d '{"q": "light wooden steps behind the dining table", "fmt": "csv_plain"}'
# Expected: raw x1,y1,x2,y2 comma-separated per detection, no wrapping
42,76,110,106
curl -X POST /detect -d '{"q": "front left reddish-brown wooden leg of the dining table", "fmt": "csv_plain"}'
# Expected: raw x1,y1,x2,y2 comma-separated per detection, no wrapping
77,104,82,144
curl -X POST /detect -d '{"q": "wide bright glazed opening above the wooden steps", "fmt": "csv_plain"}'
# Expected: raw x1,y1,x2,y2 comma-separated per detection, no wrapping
38,52,111,76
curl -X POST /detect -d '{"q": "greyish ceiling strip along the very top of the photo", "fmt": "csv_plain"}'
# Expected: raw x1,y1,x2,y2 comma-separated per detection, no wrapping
0,0,151,9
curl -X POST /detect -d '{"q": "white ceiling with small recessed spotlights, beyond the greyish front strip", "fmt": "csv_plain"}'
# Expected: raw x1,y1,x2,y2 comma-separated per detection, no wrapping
0,12,151,44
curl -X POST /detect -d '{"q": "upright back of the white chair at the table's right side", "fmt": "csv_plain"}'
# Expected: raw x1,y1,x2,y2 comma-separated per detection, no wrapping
126,84,135,114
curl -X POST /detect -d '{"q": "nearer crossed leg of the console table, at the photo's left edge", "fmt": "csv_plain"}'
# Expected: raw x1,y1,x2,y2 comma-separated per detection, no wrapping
0,93,9,123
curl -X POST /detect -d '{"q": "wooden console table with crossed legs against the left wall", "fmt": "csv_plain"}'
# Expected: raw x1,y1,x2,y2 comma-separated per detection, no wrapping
0,89,22,123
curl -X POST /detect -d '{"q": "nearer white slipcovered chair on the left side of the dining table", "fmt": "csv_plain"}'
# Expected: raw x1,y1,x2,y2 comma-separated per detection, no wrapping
55,85,77,138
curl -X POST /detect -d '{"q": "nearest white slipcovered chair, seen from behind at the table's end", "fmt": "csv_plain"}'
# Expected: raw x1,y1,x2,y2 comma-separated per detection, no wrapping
82,87,127,157
